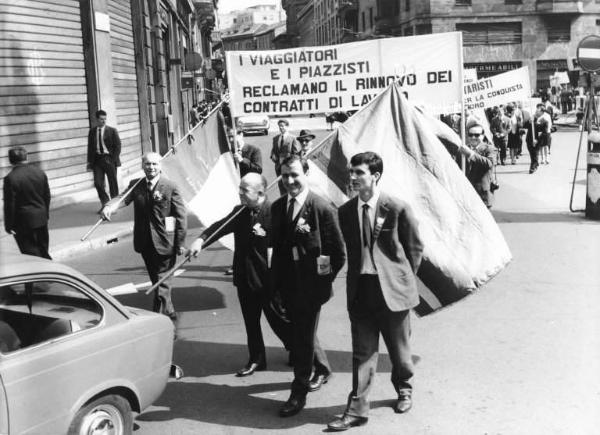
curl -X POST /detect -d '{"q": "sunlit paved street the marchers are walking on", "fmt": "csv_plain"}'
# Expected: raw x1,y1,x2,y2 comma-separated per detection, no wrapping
66,127,600,435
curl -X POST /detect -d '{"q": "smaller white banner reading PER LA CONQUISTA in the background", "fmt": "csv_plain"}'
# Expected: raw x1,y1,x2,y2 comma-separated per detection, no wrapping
464,66,531,110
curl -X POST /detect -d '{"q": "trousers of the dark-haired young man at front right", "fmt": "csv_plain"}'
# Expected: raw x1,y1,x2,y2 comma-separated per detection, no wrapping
346,275,414,417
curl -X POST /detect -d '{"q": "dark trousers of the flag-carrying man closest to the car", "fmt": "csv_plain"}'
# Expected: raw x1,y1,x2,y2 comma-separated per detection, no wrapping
141,246,176,316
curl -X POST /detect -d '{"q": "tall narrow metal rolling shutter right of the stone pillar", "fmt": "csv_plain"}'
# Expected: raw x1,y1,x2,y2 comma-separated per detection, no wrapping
108,0,142,175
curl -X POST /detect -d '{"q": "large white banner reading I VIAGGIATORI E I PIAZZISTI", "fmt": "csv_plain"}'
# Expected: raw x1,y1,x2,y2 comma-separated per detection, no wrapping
227,32,463,116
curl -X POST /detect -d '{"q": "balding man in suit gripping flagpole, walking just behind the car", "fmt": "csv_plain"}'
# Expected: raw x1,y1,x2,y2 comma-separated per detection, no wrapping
101,153,187,320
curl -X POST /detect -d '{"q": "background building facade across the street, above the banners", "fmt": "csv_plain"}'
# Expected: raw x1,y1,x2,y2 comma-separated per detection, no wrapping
290,0,600,88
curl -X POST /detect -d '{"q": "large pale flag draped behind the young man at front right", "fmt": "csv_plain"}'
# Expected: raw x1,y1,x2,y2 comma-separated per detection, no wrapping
310,85,511,315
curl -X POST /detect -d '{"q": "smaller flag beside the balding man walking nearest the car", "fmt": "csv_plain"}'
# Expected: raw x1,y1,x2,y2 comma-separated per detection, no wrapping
161,111,240,249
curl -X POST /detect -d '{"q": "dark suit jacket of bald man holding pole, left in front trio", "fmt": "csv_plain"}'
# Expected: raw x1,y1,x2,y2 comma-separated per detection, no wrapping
200,200,271,291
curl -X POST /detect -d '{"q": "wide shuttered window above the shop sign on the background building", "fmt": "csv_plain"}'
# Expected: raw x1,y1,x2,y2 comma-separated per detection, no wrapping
456,22,522,46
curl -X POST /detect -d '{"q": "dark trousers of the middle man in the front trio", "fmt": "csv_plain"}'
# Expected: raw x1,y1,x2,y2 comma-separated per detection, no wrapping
289,306,331,397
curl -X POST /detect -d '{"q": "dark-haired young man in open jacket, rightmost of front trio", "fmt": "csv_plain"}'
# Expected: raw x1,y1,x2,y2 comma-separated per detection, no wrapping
328,152,423,431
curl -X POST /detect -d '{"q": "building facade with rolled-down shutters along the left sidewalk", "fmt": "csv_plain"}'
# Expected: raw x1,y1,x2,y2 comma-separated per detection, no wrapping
0,0,216,218
